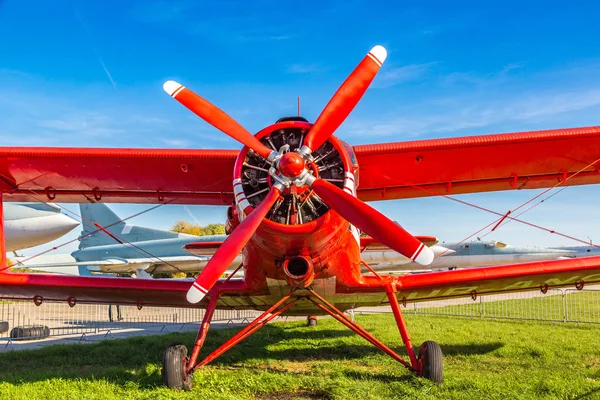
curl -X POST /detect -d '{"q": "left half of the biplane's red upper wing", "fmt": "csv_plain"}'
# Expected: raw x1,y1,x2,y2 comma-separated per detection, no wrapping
0,147,238,205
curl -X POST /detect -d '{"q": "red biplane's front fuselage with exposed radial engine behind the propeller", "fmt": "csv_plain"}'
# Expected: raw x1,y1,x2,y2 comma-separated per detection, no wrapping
223,121,388,314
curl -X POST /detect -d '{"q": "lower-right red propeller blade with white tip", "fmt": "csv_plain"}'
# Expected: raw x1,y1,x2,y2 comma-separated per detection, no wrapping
312,179,434,265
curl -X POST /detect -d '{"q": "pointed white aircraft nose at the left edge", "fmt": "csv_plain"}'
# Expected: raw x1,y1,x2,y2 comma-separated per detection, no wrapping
4,203,79,252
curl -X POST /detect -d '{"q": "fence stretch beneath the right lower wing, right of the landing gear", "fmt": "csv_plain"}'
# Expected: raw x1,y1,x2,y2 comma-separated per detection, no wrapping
394,289,600,324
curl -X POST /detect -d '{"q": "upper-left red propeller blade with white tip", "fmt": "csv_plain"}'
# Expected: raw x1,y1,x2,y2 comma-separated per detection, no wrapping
163,81,273,159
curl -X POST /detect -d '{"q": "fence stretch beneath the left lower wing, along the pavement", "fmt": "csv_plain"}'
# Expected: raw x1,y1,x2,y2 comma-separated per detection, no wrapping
0,301,260,342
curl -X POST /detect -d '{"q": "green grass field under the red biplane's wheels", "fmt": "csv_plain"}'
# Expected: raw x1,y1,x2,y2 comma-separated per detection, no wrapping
0,314,600,400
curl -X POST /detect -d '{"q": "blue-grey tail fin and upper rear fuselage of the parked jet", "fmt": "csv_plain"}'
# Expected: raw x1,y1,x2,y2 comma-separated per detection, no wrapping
79,203,179,249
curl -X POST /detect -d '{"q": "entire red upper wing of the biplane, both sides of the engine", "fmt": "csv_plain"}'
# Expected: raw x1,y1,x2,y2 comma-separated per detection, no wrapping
0,127,600,205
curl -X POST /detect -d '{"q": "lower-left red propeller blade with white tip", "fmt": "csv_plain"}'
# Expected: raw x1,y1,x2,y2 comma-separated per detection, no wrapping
186,187,281,304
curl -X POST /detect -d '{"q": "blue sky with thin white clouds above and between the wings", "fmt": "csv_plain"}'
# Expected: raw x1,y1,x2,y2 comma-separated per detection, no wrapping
0,0,600,255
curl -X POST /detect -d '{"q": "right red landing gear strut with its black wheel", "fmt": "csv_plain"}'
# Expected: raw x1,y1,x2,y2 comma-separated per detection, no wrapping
387,287,444,385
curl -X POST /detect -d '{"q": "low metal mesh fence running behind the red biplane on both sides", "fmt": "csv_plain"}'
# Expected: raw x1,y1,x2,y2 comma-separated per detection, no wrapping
0,289,600,341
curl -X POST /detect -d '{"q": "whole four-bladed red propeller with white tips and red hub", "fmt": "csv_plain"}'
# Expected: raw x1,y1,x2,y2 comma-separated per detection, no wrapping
163,46,434,303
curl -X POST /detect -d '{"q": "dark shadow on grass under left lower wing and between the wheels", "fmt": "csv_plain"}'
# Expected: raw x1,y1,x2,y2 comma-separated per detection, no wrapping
0,325,404,388
